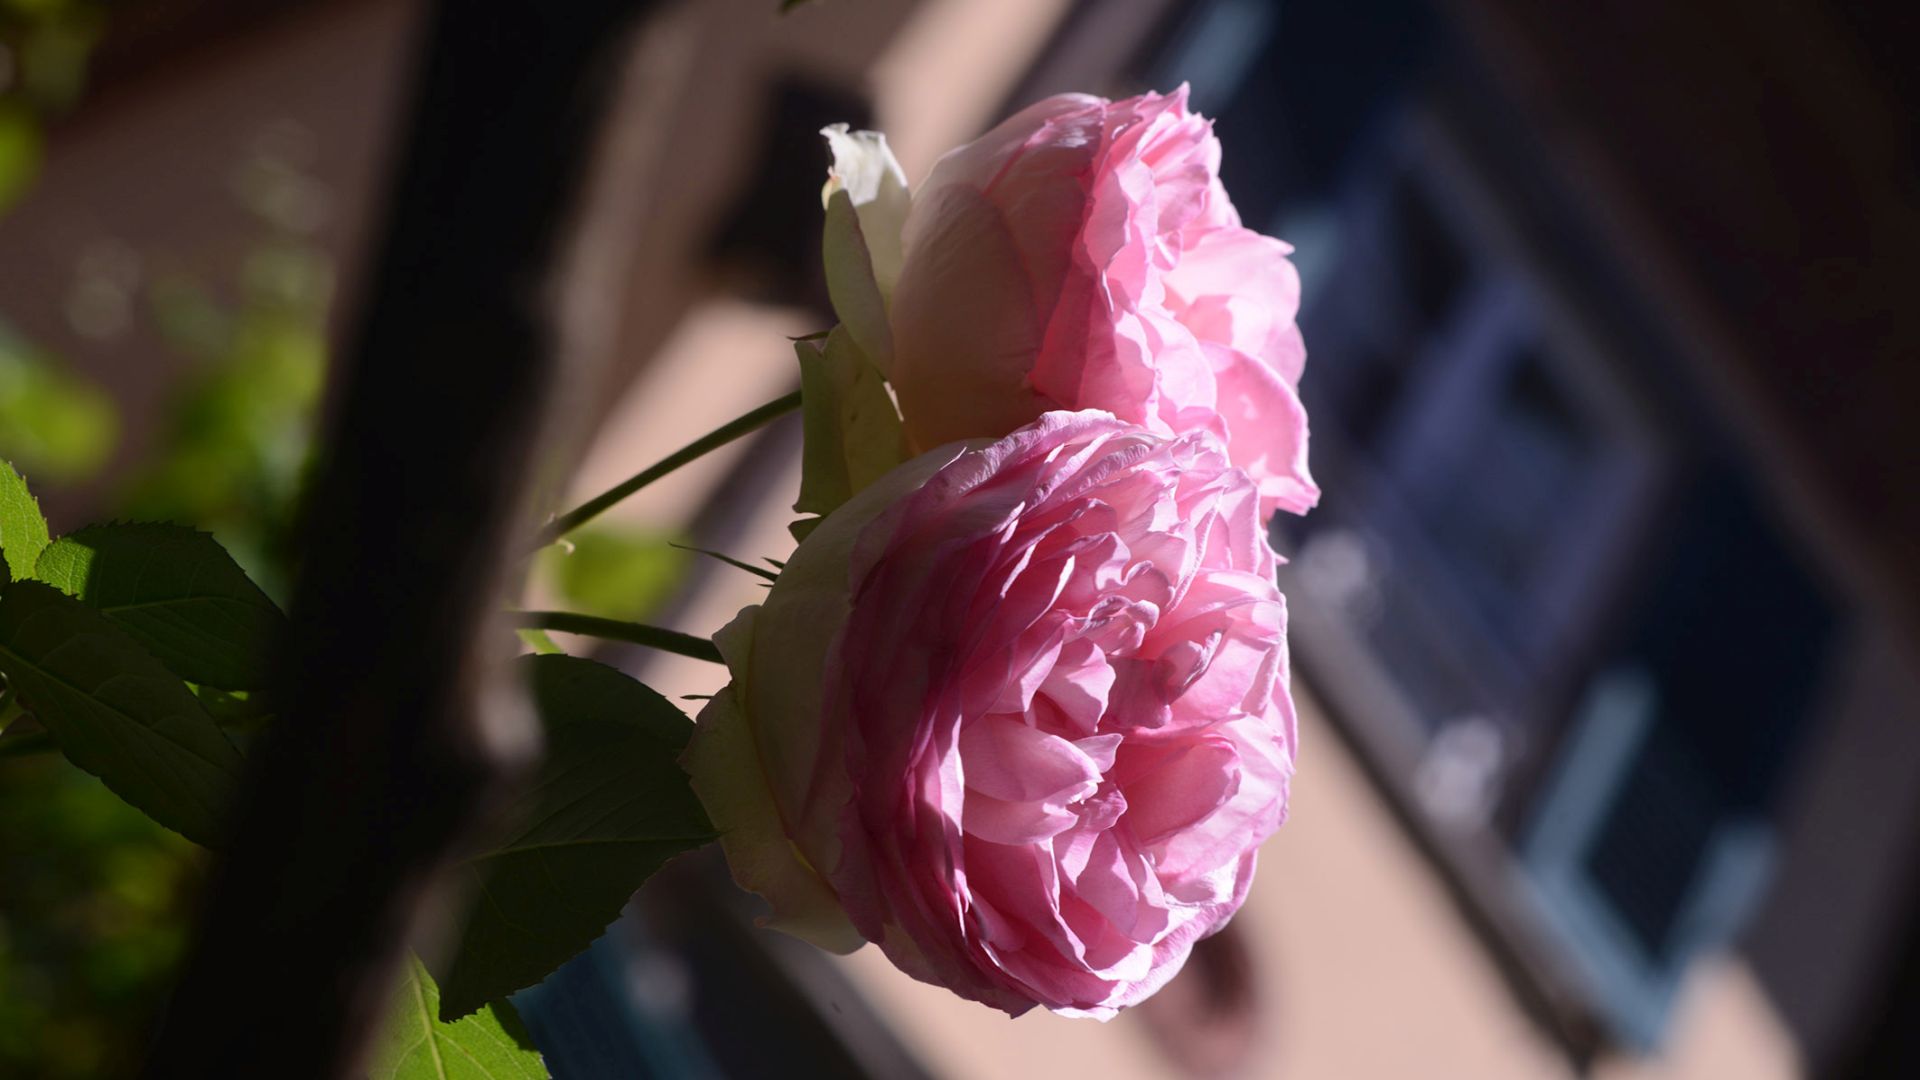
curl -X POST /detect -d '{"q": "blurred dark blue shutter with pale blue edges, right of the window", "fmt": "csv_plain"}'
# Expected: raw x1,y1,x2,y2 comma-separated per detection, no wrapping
1524,475,1837,1045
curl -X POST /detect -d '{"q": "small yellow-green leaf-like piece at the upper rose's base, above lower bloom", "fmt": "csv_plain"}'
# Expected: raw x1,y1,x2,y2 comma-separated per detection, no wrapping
793,327,906,517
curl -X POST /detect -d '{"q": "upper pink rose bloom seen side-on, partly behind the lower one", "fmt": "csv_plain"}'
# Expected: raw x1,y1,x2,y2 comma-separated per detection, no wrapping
870,86,1319,517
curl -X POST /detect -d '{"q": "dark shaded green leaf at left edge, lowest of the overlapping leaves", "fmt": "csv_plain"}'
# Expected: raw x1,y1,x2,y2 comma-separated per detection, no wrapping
0,580,242,844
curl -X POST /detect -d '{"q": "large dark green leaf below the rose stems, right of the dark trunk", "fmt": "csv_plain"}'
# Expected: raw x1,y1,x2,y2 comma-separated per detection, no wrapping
440,655,714,1019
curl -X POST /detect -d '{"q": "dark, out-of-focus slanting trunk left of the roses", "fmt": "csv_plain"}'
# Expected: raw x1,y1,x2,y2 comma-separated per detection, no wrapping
148,0,651,1078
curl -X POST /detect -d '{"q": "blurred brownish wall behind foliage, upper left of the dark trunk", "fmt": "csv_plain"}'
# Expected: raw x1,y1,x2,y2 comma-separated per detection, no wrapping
0,0,415,527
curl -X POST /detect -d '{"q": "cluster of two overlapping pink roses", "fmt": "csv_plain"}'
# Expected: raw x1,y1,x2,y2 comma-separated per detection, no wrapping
684,90,1319,1017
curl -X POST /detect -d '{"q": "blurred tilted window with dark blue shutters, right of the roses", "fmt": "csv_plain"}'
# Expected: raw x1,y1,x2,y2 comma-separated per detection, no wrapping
1140,0,1845,1045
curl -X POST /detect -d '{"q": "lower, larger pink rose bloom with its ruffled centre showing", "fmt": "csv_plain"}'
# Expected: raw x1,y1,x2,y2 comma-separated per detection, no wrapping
684,411,1296,1019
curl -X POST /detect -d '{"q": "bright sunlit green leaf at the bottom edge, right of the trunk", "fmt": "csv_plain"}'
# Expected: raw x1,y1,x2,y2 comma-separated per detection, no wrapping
369,955,547,1080
